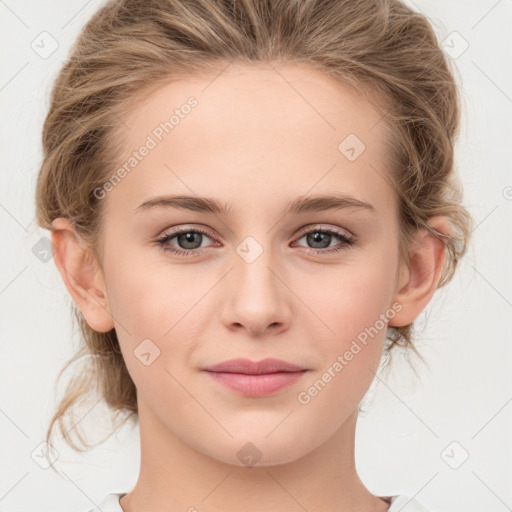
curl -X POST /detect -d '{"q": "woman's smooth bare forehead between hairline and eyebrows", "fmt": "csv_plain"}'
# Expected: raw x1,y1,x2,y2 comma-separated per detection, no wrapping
109,64,394,219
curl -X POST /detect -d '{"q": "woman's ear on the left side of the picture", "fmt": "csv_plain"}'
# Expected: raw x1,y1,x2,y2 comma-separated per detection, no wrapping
52,217,114,332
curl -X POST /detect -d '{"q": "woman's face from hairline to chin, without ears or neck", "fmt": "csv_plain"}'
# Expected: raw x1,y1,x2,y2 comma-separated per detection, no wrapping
97,65,400,466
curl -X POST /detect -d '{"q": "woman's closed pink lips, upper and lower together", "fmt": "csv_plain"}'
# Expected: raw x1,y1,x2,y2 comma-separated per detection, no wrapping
205,358,307,396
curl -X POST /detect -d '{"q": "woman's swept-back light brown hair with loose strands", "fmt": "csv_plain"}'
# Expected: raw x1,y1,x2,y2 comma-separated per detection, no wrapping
36,0,472,451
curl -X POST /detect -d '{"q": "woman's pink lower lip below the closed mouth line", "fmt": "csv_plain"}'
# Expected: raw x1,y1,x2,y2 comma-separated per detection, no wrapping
207,370,307,396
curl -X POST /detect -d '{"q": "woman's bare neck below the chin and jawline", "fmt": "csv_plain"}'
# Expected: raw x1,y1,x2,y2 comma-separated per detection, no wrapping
121,403,389,512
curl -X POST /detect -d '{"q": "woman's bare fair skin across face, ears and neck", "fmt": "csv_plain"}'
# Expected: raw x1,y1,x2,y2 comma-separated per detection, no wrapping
52,64,449,512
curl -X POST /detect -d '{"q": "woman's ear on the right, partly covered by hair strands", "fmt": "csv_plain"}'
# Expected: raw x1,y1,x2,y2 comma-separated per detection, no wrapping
388,216,450,327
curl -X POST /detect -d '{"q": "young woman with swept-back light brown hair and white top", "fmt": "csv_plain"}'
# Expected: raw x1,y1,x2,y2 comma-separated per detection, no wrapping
36,0,471,512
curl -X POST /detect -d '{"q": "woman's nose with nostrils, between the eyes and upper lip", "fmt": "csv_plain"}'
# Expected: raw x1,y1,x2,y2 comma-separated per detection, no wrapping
221,245,293,336
